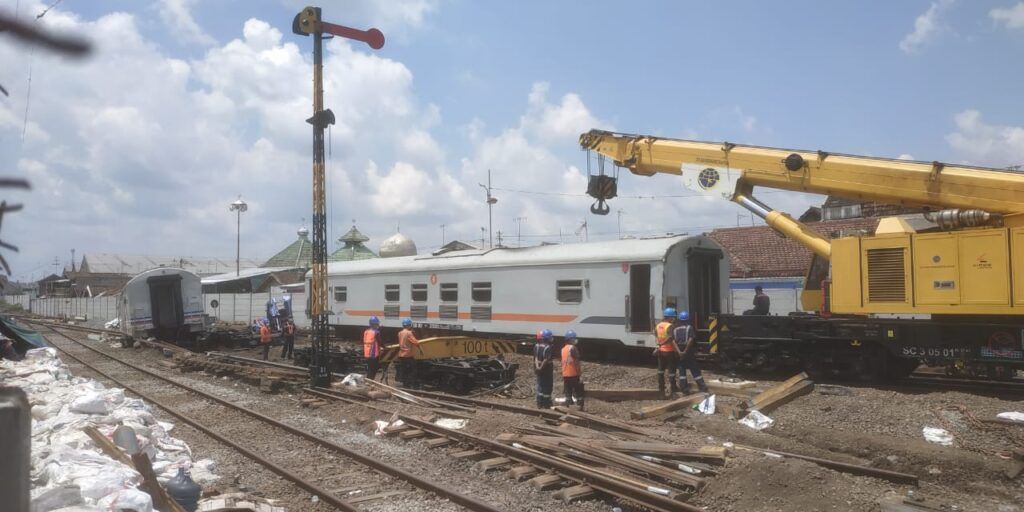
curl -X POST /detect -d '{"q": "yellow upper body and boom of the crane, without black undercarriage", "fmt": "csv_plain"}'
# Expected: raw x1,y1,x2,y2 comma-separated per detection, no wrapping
580,130,1024,315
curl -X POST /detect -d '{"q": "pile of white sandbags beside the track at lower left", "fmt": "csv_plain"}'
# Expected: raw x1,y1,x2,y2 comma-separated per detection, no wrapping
0,348,217,512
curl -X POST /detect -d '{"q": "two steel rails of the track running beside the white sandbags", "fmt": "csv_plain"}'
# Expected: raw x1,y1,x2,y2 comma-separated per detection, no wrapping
37,326,500,512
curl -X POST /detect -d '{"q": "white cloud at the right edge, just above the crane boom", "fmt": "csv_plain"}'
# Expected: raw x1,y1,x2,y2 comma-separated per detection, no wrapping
946,110,1024,167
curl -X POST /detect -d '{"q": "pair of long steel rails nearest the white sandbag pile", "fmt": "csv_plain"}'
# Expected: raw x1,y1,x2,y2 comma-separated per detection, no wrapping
41,327,501,512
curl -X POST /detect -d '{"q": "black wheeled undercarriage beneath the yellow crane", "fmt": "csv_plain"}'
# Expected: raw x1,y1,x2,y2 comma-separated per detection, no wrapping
709,314,1024,380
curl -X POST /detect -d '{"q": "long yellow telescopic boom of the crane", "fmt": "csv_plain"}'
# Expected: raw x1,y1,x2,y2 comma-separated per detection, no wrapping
580,130,1024,215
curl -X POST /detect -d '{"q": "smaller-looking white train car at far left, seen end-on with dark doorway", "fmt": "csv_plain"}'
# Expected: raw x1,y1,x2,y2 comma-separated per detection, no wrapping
118,267,204,342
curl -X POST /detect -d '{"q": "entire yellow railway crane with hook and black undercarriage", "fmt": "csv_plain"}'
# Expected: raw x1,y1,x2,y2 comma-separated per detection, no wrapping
580,130,1024,377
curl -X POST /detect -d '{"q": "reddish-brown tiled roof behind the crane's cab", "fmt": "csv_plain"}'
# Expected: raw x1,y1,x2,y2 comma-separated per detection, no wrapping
708,218,879,278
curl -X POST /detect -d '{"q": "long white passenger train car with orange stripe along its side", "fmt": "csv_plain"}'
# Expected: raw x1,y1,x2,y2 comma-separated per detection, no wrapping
323,236,730,348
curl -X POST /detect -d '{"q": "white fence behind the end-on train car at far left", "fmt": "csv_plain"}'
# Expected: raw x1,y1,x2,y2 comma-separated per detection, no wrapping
3,293,309,328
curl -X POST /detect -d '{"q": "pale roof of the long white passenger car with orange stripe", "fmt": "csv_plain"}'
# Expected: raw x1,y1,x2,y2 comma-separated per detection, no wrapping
321,234,722,276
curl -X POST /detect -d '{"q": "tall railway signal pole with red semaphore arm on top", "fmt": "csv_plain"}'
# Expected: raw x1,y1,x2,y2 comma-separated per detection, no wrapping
292,7,384,387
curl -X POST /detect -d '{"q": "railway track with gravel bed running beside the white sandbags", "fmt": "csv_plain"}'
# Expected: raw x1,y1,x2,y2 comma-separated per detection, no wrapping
38,324,500,512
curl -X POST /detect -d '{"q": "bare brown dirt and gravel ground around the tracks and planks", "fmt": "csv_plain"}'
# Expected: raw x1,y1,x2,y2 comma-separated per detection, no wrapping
51,327,1024,512
